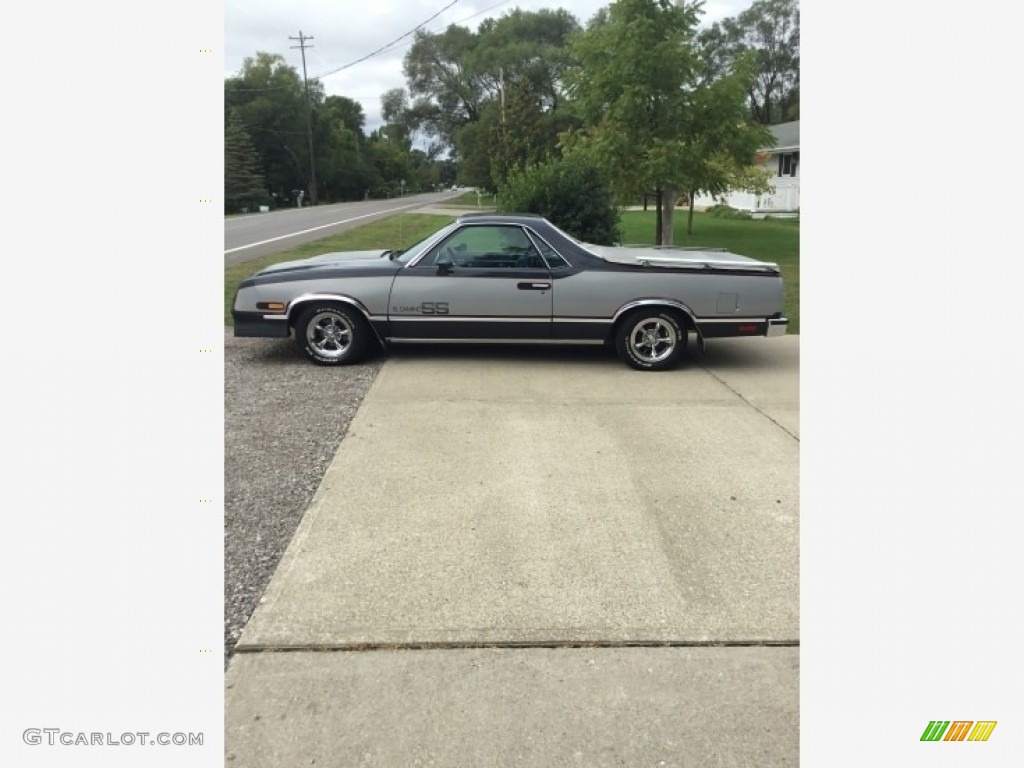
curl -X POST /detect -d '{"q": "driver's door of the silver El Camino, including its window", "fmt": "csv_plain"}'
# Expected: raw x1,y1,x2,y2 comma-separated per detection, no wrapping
388,223,553,341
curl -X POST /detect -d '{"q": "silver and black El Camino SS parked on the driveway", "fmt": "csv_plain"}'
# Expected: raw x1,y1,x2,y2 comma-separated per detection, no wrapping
232,214,788,371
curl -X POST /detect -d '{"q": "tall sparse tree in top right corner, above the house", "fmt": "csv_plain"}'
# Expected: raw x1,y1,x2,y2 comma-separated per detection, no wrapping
700,0,800,125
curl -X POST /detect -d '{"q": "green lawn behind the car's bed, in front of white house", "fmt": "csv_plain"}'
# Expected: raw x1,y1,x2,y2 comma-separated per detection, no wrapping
623,209,800,334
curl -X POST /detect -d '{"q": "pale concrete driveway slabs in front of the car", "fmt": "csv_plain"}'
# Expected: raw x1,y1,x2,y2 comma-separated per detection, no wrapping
226,337,799,766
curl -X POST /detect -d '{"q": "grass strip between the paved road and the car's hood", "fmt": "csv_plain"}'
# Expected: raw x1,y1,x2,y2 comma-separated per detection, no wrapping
224,213,455,326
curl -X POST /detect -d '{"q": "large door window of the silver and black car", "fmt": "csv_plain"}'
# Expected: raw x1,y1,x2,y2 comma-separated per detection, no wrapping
417,224,545,269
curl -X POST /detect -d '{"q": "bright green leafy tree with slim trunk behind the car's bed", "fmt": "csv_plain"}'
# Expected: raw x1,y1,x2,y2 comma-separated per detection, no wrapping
566,0,768,240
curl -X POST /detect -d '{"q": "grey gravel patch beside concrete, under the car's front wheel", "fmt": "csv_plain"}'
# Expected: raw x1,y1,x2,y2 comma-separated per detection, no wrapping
224,328,383,662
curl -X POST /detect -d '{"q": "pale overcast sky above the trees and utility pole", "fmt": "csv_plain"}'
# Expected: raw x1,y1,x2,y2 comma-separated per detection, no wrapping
224,0,753,133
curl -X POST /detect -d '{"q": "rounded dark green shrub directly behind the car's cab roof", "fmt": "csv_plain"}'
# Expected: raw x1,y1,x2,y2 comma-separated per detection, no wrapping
498,157,621,245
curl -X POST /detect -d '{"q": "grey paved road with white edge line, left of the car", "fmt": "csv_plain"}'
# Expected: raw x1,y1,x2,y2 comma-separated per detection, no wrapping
224,191,460,266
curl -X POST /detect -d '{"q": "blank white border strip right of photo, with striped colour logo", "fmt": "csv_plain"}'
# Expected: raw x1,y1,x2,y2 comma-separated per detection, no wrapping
801,0,1024,768
